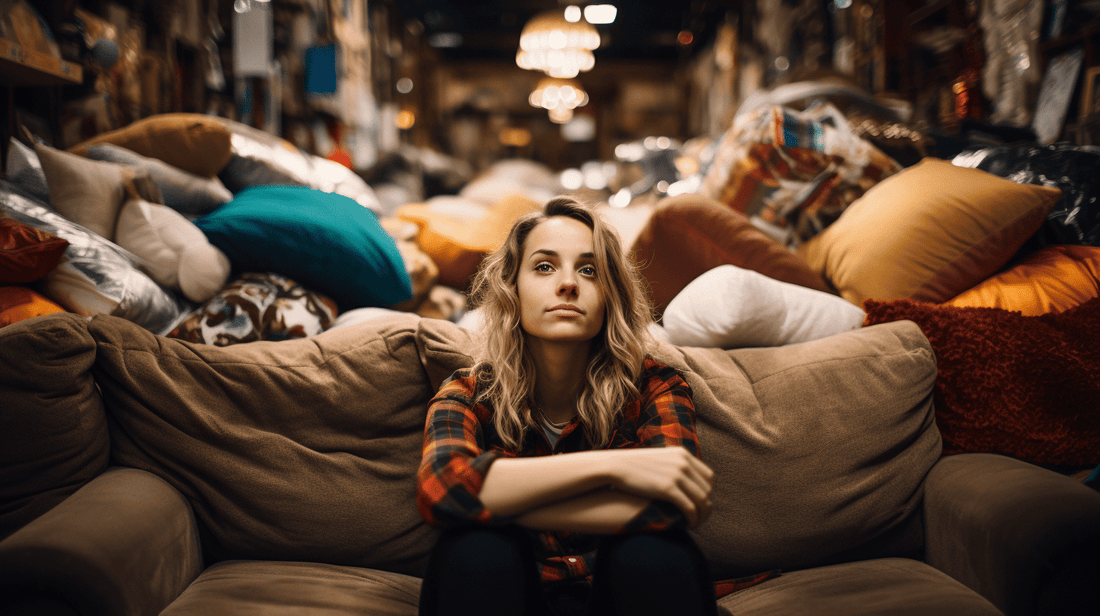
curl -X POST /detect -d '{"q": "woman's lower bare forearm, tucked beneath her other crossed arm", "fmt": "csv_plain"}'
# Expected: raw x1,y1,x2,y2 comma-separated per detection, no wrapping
516,488,649,535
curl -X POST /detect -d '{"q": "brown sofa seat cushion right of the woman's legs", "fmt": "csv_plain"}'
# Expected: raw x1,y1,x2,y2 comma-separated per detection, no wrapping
718,558,1001,616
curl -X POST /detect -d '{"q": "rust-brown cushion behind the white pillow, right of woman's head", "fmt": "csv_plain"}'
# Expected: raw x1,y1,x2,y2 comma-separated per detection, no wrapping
633,195,833,314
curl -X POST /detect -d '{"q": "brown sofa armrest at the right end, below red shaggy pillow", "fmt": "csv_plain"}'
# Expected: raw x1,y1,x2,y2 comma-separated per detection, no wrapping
924,453,1100,616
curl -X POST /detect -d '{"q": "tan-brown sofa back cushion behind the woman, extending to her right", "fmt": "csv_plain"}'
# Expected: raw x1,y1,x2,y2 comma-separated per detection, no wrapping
418,319,941,579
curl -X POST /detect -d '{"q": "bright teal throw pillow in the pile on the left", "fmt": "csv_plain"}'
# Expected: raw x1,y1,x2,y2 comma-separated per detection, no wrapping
195,186,413,311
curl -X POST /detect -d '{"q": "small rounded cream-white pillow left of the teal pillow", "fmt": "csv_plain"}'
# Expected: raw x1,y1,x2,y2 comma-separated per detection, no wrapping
114,199,231,303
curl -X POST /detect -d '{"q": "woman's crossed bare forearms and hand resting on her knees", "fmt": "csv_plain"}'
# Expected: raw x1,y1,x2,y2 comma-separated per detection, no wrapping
479,447,714,531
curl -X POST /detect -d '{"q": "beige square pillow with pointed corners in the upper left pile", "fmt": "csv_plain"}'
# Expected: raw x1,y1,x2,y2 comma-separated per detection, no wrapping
34,143,134,240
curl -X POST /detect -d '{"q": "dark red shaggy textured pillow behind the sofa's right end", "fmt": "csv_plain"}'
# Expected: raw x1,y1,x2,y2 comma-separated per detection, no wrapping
864,298,1100,465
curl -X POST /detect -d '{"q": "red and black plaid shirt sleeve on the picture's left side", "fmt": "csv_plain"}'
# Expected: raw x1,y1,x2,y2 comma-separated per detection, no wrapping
417,370,499,526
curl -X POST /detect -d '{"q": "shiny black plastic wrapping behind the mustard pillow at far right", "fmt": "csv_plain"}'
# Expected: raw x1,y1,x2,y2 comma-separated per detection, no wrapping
953,143,1100,252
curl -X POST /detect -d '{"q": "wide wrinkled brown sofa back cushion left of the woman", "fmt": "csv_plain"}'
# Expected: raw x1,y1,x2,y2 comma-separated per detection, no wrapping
89,314,436,574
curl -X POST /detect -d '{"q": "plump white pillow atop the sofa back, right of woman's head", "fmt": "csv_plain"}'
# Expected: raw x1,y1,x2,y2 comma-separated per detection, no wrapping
664,265,866,349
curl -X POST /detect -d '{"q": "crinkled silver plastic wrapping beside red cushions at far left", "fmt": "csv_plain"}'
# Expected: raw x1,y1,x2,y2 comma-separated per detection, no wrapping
0,180,190,334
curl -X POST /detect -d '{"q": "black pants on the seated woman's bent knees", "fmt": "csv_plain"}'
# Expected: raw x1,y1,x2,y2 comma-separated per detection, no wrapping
420,527,717,616
